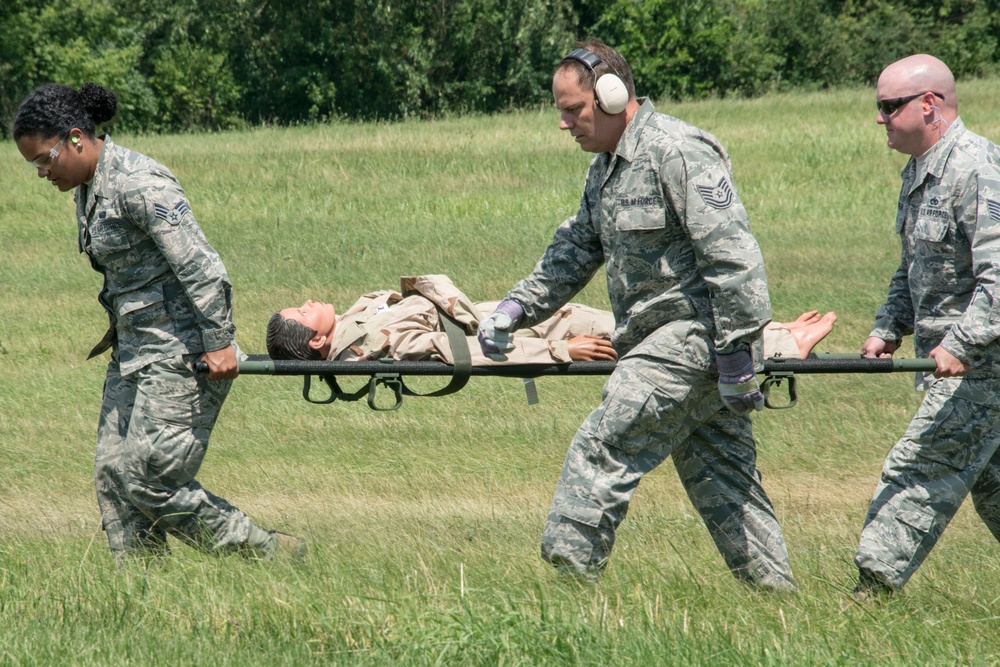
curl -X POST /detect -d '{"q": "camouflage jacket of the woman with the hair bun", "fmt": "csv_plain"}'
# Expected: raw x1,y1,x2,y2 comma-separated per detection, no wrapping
76,136,236,375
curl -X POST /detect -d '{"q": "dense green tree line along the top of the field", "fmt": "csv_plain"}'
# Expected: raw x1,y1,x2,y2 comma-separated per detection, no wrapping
0,0,1000,136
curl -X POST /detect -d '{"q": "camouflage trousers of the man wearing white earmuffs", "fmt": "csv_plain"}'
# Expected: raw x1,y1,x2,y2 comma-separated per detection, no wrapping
542,356,795,590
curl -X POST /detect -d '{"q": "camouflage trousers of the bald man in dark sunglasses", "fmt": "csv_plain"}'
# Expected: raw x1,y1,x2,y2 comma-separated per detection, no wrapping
854,378,1000,589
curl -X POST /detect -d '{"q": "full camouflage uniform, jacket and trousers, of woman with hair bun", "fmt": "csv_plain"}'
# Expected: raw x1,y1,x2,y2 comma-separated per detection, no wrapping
76,136,273,559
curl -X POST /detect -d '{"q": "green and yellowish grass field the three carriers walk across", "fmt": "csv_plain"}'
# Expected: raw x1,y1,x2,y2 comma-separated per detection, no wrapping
0,80,1000,665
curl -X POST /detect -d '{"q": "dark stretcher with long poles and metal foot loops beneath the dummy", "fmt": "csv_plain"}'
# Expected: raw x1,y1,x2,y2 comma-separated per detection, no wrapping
196,353,937,410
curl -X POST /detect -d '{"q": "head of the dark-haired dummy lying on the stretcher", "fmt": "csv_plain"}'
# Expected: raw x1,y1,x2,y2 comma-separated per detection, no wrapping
267,300,337,361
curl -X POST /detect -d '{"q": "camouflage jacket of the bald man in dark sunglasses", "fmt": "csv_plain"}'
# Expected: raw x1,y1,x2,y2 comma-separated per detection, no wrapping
871,119,1000,376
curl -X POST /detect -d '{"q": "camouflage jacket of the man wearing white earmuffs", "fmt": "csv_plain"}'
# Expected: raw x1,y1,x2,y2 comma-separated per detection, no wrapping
507,100,771,369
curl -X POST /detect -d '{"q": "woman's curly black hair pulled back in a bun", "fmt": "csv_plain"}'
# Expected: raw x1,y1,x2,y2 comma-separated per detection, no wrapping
12,83,118,141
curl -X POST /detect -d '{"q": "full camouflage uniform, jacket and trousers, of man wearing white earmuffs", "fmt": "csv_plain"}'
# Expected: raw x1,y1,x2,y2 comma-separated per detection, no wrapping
507,101,795,590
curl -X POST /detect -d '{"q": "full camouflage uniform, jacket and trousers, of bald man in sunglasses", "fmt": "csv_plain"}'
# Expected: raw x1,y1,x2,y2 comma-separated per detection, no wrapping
854,119,1000,589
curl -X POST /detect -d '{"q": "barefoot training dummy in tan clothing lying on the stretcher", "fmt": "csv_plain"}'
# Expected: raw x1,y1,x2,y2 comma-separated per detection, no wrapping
267,275,836,366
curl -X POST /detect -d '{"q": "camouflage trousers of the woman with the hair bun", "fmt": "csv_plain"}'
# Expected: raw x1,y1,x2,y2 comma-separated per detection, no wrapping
94,355,269,562
